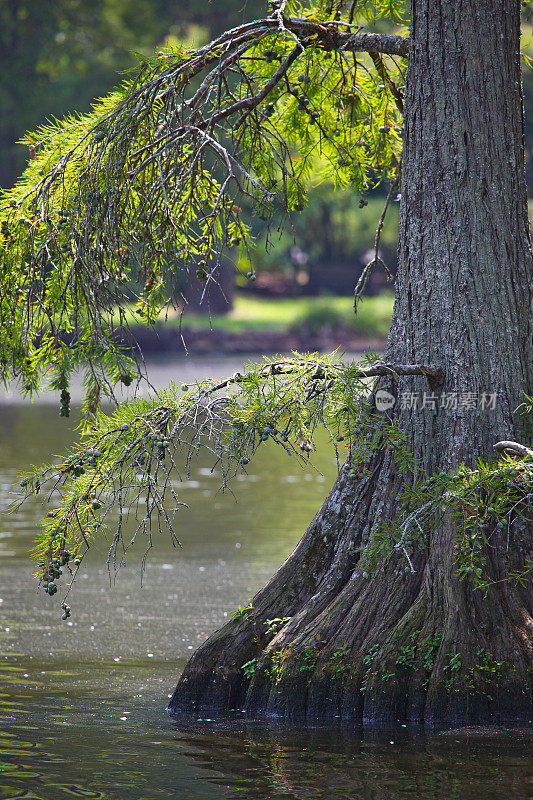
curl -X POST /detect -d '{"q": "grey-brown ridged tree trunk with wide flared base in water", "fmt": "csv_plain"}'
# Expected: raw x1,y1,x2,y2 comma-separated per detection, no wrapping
169,0,533,724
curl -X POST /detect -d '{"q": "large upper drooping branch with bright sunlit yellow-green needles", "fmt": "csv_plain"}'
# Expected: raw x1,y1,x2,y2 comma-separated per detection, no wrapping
0,0,406,418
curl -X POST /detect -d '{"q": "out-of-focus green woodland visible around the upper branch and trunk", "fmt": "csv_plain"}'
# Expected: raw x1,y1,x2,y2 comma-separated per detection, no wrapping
0,0,533,306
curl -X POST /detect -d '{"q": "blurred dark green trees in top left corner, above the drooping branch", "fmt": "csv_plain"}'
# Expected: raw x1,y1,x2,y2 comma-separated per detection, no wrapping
0,0,268,187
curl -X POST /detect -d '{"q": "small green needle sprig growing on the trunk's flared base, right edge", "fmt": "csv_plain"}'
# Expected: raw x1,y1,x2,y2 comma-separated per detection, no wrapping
358,454,533,590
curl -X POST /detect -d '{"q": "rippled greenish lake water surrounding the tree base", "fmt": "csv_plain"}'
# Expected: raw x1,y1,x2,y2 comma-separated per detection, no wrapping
0,359,533,800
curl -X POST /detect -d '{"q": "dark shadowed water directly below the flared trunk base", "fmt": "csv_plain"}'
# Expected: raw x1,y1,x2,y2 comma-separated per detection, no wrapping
166,722,533,800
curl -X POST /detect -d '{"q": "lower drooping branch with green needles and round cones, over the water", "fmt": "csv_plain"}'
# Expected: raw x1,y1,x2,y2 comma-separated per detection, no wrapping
14,354,408,575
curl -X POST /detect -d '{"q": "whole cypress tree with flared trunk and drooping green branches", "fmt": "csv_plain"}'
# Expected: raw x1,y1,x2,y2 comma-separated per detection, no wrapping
0,0,533,721
